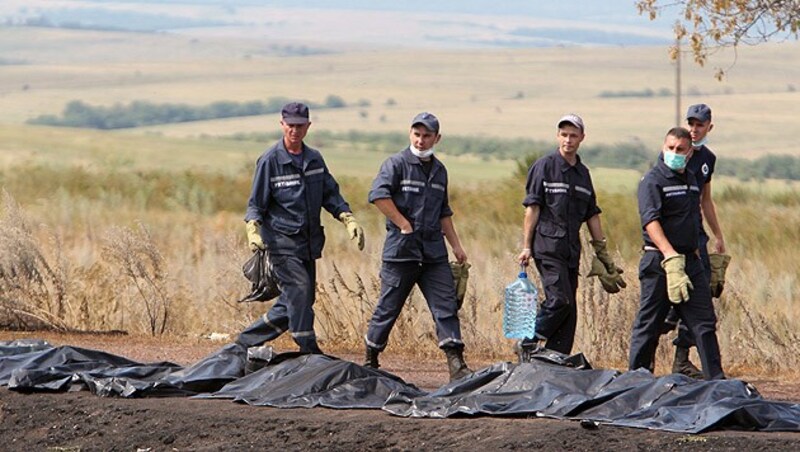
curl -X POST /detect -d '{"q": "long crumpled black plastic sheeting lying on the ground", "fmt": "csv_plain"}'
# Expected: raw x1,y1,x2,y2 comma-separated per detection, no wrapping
0,340,800,433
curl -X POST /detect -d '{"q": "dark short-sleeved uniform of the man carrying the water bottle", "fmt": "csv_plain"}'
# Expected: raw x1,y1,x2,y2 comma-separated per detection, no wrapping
522,150,600,354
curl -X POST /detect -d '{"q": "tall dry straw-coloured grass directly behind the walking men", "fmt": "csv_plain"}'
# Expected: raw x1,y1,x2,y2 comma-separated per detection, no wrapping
0,163,800,375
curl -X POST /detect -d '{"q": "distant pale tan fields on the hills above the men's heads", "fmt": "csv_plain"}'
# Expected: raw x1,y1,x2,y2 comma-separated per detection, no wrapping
0,28,800,157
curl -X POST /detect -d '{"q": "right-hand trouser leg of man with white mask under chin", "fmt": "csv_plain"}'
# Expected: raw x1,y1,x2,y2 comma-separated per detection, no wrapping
417,262,464,348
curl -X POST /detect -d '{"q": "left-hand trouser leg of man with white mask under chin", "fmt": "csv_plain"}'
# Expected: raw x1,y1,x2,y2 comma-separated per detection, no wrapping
364,262,418,350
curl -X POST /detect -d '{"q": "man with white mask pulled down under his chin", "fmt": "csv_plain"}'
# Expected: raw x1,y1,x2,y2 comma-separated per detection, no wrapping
365,113,471,380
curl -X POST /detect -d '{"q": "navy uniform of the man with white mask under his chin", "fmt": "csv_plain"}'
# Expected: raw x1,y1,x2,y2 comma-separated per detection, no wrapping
365,148,464,350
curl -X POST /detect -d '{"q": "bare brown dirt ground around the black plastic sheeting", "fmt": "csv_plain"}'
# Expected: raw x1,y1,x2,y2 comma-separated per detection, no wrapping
0,332,800,451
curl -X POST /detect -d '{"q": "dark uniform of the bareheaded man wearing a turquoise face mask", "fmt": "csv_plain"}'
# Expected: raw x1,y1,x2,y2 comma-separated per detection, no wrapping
629,160,725,380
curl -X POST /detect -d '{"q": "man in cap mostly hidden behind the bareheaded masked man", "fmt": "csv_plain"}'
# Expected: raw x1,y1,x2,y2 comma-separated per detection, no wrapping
661,104,730,378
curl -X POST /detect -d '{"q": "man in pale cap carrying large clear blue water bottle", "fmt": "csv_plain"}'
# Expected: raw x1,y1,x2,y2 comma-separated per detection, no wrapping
517,114,626,362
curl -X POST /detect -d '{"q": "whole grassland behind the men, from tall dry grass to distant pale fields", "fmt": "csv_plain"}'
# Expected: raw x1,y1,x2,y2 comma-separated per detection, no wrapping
0,27,800,374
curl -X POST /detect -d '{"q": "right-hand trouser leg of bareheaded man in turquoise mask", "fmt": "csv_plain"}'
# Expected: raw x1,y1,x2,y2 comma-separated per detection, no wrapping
678,256,725,380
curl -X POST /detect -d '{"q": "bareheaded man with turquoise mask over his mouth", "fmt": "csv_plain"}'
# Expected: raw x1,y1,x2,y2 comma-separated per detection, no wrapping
629,127,725,380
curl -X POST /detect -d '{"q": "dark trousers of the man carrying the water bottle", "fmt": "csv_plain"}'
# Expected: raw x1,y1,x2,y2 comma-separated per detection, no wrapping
535,259,578,354
